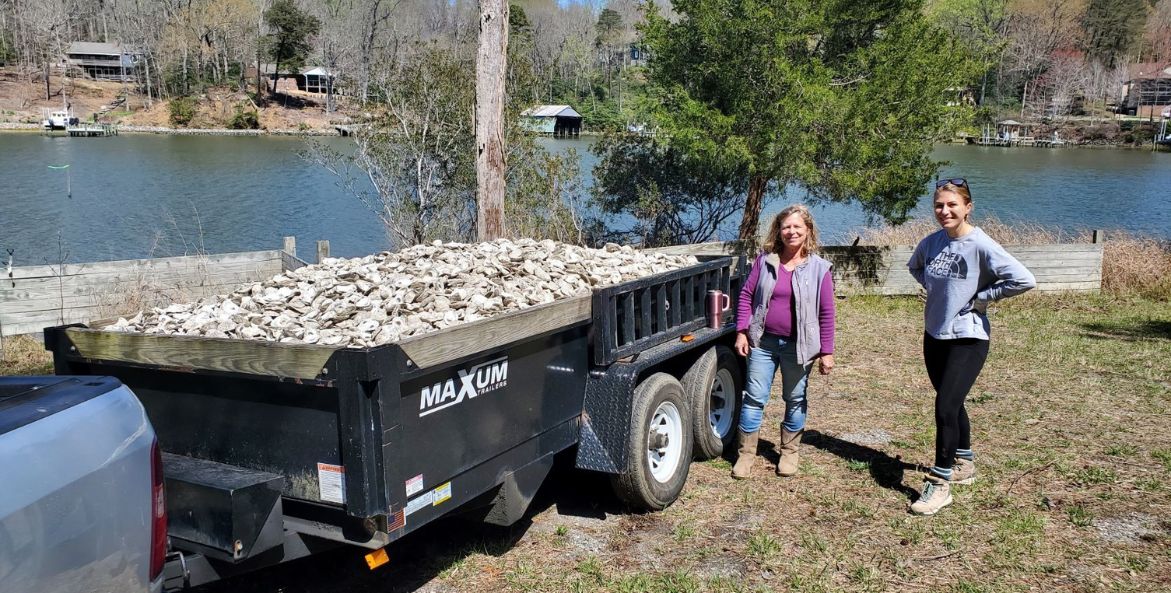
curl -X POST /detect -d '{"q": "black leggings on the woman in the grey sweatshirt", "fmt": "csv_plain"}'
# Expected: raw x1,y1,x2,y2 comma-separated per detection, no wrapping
923,334,988,468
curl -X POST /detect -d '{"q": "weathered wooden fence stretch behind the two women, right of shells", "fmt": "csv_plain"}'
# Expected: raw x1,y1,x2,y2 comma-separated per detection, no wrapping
657,231,1103,294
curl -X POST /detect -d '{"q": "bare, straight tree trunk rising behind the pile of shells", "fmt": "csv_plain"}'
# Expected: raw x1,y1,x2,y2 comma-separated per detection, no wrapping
475,0,508,241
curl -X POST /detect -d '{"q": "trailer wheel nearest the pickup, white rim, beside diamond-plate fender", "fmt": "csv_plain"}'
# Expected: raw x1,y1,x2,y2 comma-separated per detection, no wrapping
611,373,692,511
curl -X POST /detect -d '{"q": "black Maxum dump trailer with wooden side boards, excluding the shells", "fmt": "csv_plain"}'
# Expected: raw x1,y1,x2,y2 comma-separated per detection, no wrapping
44,257,745,589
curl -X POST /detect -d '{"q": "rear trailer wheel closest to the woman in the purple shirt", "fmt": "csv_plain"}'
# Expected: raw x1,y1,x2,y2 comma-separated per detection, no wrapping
683,346,744,461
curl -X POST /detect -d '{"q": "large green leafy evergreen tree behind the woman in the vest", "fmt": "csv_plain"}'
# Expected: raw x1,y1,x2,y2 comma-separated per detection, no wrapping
645,0,971,245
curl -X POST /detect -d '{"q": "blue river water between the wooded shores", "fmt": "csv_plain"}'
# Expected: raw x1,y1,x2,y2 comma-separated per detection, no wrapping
0,134,1171,265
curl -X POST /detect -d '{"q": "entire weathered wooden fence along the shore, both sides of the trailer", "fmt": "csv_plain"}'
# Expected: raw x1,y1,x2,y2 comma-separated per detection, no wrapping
0,231,1102,336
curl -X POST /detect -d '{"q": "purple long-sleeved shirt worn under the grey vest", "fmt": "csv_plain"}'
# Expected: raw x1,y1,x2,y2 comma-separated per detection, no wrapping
735,257,835,354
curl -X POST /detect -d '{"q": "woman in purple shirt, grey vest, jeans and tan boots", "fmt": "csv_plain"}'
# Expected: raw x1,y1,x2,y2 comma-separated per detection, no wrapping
732,204,834,479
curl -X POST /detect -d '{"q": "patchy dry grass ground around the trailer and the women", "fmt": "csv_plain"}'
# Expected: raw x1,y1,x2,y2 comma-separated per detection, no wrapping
4,289,1171,593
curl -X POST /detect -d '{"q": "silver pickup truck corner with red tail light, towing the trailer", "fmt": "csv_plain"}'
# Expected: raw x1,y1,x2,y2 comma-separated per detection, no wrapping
0,376,166,593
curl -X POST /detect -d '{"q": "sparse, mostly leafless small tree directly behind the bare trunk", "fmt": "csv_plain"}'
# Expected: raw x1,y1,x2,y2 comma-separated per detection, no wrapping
307,43,587,247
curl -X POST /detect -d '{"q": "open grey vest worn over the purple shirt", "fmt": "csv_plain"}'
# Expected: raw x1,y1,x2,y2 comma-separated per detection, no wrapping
748,253,833,364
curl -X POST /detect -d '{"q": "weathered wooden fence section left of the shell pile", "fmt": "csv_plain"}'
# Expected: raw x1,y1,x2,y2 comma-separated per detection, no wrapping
0,237,316,335
